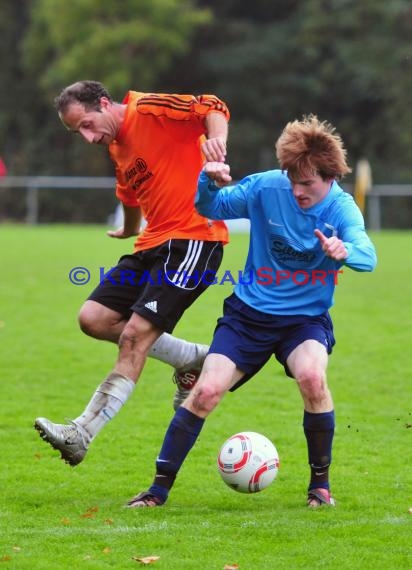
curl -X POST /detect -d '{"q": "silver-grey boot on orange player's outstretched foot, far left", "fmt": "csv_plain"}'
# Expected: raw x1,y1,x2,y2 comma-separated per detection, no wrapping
34,418,88,467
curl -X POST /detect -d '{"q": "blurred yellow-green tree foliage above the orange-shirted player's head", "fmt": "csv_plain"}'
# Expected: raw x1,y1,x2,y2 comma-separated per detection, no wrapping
24,0,211,94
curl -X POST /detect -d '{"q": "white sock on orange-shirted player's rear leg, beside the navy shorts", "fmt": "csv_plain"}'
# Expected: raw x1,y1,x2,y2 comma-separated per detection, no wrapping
149,333,209,370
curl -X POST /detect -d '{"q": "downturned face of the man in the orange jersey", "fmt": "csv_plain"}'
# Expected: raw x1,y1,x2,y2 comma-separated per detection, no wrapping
60,97,120,145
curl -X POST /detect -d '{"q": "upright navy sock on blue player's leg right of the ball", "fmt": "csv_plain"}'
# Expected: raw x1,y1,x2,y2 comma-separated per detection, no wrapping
303,410,335,490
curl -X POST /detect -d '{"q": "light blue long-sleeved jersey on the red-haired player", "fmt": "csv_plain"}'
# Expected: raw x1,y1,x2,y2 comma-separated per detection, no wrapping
195,170,376,316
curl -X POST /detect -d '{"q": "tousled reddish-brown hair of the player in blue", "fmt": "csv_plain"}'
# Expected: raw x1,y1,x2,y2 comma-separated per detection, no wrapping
276,115,351,180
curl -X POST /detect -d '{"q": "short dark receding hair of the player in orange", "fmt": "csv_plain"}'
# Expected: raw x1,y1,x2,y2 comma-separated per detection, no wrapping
54,81,112,114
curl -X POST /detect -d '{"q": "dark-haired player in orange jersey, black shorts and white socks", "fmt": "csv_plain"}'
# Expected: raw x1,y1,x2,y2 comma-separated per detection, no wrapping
35,81,229,466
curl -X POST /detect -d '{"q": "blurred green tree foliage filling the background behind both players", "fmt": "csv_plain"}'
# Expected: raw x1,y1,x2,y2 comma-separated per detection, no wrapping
0,0,412,221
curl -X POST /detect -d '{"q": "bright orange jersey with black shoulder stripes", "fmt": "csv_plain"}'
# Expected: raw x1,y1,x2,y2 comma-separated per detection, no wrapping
109,91,229,252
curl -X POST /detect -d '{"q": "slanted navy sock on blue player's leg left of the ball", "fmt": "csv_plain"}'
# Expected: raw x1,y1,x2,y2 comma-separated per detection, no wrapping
149,407,205,502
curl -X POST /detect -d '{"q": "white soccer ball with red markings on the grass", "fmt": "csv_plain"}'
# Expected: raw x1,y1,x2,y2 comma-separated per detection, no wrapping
217,431,279,493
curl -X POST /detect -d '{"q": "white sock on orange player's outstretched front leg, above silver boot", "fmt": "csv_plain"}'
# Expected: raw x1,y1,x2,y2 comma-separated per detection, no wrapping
73,372,136,443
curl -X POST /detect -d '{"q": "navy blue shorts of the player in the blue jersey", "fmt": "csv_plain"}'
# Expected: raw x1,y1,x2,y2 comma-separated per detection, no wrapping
209,293,335,391
